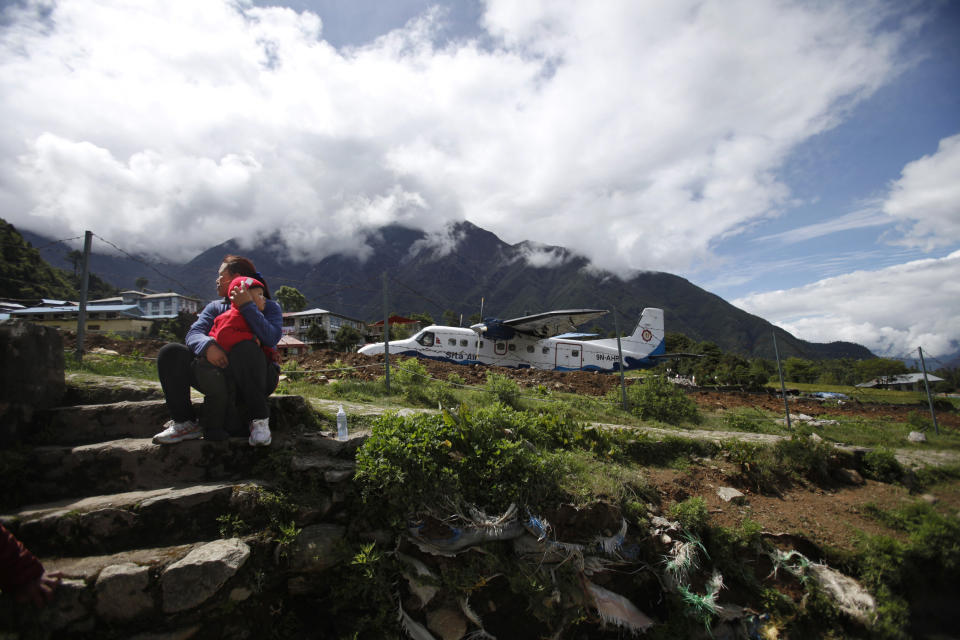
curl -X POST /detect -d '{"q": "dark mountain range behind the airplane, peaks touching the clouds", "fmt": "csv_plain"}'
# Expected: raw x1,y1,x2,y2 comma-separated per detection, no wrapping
16,222,874,359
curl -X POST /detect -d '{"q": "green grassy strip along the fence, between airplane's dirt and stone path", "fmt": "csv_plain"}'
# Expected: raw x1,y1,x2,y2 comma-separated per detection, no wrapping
66,353,960,451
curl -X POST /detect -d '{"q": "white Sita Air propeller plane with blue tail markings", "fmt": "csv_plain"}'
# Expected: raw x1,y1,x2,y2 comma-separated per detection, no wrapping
359,307,671,373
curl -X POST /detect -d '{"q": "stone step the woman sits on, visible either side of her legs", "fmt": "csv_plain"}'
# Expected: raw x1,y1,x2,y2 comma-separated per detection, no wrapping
26,396,315,445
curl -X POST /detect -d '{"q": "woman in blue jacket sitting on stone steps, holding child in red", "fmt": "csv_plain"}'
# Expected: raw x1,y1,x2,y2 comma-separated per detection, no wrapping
153,255,283,446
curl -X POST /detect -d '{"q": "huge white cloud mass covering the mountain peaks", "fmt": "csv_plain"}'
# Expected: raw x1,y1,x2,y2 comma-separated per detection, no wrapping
0,0,916,272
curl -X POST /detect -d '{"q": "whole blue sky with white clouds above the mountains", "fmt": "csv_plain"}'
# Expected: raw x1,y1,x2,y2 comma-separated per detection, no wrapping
0,0,960,364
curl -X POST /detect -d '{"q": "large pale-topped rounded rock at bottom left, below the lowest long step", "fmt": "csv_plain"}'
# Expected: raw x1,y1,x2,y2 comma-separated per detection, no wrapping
160,538,250,613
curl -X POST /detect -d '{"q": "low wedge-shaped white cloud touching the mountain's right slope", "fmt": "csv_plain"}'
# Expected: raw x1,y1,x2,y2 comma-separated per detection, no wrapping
732,251,960,357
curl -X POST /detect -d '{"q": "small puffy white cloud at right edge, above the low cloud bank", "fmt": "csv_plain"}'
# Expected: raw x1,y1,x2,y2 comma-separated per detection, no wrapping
883,134,960,251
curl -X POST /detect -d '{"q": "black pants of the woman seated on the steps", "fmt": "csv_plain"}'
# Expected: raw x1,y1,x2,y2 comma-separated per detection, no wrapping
157,340,279,435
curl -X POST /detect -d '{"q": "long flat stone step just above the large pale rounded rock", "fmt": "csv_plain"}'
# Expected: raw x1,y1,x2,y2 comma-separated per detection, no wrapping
0,480,267,555
